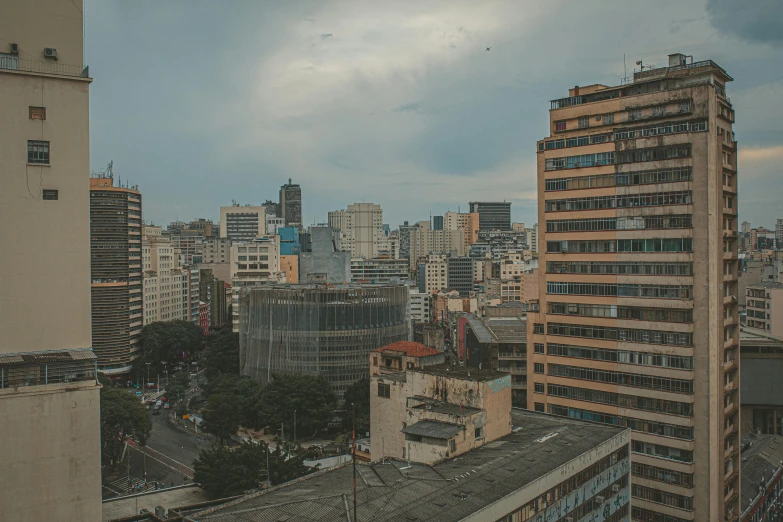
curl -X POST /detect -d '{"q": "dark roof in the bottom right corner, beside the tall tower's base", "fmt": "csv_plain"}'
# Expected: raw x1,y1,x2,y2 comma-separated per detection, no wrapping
740,434,783,514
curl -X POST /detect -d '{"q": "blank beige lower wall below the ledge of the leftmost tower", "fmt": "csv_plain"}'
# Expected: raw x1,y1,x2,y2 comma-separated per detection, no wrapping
0,381,101,522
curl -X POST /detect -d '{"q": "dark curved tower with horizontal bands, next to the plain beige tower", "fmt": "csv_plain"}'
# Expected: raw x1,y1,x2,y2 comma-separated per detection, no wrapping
89,171,144,375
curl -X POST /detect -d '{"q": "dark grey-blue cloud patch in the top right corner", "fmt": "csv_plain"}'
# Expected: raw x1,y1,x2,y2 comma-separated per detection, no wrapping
707,0,783,46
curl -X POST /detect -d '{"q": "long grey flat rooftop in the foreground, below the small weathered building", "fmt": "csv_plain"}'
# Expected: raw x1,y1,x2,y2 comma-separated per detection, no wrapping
190,409,624,522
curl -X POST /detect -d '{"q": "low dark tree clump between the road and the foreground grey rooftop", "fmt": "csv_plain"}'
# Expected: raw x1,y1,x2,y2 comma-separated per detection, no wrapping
193,442,317,498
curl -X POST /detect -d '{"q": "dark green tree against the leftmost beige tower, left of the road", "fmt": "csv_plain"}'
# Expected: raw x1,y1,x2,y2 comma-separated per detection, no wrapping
101,386,152,469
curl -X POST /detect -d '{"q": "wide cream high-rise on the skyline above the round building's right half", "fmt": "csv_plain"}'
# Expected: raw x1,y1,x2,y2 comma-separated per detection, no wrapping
329,203,386,259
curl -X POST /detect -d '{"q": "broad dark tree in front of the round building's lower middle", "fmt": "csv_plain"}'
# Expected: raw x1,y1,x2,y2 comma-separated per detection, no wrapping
258,374,337,435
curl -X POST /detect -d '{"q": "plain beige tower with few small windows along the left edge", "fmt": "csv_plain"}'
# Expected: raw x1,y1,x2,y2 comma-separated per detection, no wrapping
0,0,102,520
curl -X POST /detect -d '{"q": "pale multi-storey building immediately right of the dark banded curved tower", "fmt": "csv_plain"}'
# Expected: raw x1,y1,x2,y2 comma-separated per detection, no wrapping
141,226,190,325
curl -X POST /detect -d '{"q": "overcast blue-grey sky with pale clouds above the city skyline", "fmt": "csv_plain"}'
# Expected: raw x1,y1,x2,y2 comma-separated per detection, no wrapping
85,0,783,227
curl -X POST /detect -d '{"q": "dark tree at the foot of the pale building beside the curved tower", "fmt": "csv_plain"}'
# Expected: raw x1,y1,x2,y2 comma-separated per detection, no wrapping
134,320,204,376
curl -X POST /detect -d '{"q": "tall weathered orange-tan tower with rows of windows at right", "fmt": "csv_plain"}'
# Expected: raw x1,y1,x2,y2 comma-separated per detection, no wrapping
528,54,740,522
